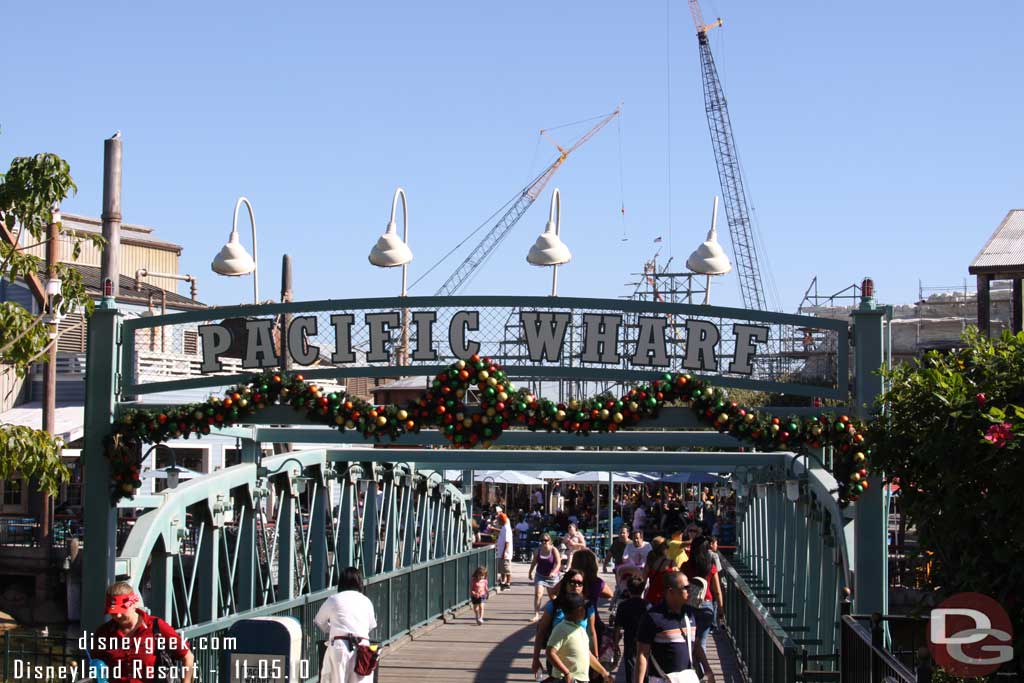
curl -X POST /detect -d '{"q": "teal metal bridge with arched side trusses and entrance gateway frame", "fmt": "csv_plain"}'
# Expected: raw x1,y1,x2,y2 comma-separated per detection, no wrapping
83,297,887,680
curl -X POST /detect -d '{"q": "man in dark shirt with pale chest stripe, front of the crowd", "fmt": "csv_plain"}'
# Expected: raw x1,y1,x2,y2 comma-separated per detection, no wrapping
630,571,715,683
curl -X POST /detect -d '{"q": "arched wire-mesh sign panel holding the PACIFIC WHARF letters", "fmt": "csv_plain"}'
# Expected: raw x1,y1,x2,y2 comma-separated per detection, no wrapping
122,296,849,399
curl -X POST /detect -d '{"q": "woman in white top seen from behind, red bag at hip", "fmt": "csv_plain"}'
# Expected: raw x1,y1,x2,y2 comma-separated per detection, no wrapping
313,567,377,683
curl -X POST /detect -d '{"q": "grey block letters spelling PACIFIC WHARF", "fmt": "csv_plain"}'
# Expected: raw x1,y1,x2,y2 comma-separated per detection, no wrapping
199,310,769,375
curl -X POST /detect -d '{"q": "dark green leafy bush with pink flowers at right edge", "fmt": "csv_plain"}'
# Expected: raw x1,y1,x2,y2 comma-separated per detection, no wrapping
872,329,1024,647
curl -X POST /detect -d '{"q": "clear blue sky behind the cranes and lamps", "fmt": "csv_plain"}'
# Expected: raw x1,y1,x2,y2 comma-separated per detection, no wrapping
0,0,1024,310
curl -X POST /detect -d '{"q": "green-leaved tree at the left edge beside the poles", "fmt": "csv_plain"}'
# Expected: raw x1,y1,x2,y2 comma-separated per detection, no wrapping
0,154,103,494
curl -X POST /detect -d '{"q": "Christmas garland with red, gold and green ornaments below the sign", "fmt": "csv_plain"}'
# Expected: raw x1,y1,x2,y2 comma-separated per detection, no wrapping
108,355,870,506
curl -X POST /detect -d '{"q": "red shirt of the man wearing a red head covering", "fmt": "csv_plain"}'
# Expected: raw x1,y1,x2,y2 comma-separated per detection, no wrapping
92,609,188,683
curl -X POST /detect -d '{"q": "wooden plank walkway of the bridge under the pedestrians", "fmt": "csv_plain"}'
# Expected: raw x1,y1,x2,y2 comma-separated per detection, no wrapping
378,563,741,683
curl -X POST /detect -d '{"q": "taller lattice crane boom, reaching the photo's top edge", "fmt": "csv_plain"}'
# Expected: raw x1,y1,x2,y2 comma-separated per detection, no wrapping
689,0,769,310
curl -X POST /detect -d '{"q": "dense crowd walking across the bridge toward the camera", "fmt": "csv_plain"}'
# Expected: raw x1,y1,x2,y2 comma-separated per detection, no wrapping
470,488,734,683
